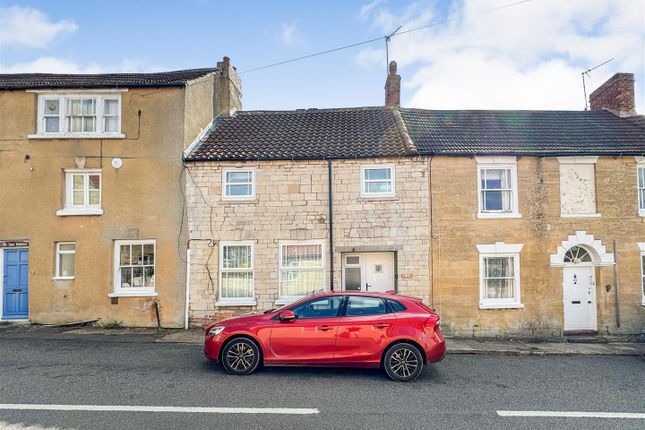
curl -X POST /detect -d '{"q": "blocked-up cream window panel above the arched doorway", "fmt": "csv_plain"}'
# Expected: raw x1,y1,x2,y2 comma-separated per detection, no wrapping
558,157,600,218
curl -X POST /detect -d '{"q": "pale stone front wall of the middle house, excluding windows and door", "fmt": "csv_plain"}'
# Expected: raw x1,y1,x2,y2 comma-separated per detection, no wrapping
187,158,430,325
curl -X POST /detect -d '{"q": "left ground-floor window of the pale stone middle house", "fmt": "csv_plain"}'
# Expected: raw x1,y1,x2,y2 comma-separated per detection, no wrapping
218,242,255,305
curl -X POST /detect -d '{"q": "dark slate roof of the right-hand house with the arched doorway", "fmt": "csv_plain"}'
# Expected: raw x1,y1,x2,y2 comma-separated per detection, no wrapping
401,109,645,155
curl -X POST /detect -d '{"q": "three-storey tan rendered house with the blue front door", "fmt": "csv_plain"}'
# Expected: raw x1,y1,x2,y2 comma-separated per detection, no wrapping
0,58,241,327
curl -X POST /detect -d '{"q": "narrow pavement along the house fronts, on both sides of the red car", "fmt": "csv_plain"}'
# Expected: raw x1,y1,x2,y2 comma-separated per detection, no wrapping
0,324,645,357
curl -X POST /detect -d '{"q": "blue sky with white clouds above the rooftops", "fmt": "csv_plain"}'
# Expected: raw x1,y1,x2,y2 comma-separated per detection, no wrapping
0,0,645,113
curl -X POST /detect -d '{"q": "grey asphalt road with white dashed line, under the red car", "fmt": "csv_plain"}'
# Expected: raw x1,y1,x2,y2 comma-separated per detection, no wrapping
0,332,645,430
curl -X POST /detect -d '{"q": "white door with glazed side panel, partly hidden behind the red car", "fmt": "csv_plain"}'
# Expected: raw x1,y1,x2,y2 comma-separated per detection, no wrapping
343,252,394,293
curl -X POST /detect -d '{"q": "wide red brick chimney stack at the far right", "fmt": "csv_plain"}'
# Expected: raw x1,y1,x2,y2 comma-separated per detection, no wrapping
589,73,636,116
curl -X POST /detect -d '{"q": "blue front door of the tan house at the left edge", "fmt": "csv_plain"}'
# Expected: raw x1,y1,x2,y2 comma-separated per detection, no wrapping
2,249,29,319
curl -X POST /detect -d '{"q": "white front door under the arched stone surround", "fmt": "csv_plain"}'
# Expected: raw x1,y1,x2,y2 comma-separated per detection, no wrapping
562,265,597,331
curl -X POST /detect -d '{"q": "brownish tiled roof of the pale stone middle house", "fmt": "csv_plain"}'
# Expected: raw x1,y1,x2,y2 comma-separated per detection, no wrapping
187,107,417,161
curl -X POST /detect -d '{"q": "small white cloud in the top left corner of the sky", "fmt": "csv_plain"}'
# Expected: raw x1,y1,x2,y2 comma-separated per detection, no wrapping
0,5,78,48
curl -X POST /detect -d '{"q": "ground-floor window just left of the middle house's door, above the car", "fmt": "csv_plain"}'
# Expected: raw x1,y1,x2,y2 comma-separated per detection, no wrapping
279,242,325,303
